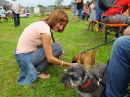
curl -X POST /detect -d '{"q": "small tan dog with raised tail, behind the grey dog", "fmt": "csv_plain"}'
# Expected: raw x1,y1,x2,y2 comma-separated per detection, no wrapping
72,48,97,70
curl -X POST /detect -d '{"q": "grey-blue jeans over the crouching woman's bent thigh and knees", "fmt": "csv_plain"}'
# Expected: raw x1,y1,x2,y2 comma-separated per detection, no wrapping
30,43,62,72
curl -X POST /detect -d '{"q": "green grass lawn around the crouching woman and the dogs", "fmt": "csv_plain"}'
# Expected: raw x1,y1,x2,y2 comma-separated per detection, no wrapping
0,13,114,97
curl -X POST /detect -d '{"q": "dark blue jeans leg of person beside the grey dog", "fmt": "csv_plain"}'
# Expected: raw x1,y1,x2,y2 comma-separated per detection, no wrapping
102,35,130,97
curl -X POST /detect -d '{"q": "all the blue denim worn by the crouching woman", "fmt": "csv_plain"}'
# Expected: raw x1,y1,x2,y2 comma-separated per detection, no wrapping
13,43,62,85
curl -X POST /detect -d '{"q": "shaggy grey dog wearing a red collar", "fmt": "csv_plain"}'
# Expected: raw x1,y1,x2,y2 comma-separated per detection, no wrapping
60,64,107,97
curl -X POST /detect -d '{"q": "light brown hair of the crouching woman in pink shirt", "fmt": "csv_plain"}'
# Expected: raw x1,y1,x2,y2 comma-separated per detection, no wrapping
39,9,68,32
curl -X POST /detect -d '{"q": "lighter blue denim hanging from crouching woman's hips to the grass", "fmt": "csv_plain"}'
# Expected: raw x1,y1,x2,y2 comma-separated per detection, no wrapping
13,50,38,85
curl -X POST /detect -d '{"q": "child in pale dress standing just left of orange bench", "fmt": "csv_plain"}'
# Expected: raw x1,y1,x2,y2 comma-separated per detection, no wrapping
87,0,96,31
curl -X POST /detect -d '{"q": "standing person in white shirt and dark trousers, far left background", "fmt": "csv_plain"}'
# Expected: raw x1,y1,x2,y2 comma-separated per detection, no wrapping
10,0,21,27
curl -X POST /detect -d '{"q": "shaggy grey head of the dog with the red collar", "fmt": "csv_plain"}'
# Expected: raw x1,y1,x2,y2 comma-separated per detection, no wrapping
61,64,93,89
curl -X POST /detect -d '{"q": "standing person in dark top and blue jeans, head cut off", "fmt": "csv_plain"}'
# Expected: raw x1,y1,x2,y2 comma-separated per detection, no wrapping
76,0,83,22
